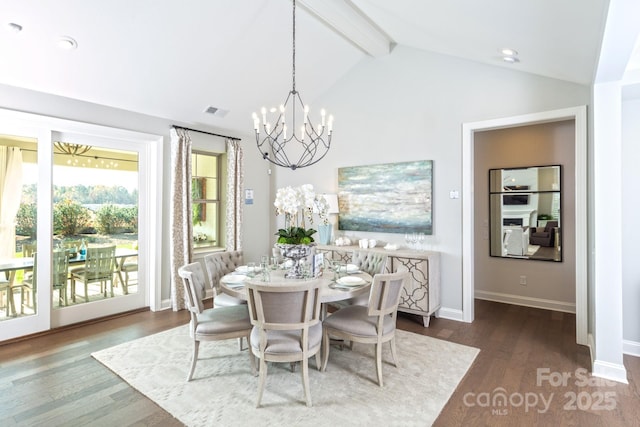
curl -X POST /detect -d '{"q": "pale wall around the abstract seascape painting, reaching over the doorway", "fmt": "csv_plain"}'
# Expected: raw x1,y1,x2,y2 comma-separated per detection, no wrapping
266,46,589,311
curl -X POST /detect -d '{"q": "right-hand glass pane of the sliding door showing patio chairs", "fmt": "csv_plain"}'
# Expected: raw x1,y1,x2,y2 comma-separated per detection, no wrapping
51,132,145,325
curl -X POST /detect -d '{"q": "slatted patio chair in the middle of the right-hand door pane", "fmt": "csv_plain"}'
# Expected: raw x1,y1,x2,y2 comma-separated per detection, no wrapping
69,245,116,302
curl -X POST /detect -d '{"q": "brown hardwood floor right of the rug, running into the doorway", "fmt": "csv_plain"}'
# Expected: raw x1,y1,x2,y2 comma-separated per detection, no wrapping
410,300,640,427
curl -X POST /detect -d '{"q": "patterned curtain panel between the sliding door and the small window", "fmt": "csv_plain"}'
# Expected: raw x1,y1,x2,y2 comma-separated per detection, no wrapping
170,128,193,311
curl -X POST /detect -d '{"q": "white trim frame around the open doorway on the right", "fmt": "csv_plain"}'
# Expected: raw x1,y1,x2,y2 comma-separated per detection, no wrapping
462,106,588,345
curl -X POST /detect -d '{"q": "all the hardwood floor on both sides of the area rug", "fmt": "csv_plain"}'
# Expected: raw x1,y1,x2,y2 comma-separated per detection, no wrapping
0,300,640,426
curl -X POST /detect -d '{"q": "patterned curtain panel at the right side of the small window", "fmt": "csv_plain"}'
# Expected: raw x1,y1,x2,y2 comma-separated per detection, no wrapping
226,139,244,251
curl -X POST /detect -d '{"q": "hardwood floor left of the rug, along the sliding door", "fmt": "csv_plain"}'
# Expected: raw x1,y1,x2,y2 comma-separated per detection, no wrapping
0,310,189,427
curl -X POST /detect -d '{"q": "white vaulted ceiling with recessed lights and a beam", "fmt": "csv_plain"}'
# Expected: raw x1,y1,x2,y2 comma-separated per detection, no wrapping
0,0,628,137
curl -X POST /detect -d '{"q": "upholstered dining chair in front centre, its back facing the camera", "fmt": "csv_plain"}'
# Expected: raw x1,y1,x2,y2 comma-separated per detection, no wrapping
246,281,322,407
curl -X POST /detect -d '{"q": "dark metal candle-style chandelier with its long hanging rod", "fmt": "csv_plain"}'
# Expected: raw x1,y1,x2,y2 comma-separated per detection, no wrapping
253,0,333,170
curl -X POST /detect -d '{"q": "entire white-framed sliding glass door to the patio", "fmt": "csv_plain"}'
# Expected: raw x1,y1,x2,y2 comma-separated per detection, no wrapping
0,110,162,341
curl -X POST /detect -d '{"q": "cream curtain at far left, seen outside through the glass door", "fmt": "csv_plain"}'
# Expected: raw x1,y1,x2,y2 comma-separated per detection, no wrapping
0,147,22,259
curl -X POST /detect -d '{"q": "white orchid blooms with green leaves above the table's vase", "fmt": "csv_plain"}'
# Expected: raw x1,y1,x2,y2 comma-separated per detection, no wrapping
273,184,329,244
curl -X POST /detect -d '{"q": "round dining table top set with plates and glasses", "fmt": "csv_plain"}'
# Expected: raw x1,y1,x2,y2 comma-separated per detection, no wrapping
220,269,372,303
